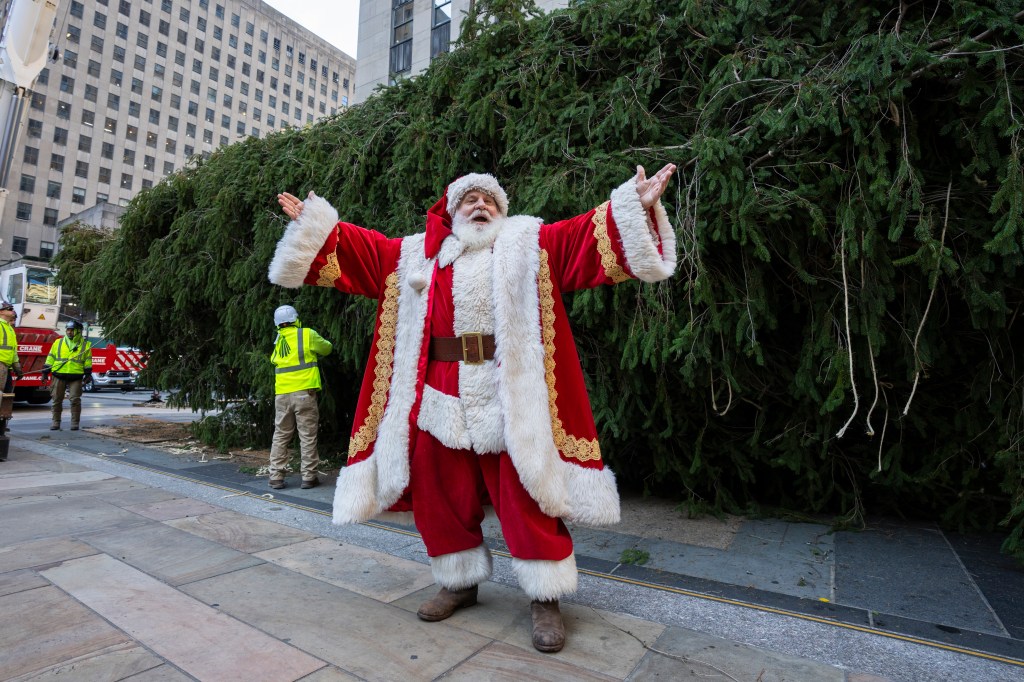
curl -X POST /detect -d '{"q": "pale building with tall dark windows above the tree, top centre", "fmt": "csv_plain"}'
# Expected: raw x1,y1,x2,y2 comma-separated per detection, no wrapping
354,0,569,102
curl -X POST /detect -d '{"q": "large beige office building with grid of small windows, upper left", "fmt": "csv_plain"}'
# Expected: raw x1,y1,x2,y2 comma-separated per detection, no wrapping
0,0,355,261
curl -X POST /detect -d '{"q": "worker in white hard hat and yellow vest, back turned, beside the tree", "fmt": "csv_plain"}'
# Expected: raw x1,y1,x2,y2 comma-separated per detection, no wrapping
270,305,333,489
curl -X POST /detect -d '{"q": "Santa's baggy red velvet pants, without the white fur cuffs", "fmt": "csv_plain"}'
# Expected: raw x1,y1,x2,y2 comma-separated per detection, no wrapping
410,431,572,561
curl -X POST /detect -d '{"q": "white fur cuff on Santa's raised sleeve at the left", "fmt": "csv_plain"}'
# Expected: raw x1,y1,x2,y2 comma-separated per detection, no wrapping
267,195,338,289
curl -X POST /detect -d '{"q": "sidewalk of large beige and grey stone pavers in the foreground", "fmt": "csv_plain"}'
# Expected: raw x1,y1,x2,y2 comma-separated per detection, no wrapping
0,447,878,682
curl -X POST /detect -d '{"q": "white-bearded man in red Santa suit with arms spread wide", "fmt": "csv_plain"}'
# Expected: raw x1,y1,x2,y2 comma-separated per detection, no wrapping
269,164,676,651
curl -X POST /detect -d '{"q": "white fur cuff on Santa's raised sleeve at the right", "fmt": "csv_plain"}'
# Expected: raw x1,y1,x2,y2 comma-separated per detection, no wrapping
611,176,676,282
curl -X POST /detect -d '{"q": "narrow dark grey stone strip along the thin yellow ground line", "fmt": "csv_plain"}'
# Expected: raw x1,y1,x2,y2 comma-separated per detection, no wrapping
14,430,1024,665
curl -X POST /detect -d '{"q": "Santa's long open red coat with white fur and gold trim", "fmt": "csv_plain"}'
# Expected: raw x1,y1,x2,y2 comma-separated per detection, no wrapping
270,174,676,524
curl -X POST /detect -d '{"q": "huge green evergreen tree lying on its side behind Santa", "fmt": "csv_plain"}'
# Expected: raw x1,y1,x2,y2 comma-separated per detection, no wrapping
61,0,1024,556
